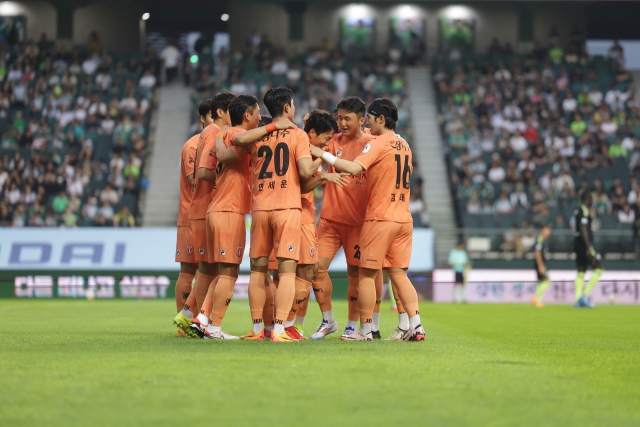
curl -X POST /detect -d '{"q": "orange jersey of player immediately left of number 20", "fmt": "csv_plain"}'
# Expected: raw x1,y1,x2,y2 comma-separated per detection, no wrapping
207,127,253,214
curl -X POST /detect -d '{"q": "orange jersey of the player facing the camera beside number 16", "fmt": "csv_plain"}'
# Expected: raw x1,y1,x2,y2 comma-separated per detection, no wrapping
320,133,373,226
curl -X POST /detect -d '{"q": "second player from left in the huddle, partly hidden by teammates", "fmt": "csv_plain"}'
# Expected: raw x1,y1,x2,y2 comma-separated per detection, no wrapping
174,92,235,336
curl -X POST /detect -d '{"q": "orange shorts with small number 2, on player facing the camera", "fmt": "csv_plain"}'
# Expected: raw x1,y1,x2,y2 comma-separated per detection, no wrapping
318,218,362,265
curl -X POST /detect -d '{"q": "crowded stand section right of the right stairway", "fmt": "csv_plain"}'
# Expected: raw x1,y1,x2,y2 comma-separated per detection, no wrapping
432,41,640,253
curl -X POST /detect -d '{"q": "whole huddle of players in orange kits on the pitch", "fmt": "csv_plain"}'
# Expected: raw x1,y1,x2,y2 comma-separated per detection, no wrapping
169,87,425,342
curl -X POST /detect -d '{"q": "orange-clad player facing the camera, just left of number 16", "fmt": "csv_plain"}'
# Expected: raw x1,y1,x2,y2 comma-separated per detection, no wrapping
310,96,382,339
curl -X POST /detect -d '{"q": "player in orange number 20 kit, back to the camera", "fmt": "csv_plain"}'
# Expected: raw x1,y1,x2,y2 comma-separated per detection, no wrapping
235,88,322,342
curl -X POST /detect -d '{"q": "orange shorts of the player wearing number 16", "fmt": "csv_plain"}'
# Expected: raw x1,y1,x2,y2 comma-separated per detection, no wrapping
360,220,413,270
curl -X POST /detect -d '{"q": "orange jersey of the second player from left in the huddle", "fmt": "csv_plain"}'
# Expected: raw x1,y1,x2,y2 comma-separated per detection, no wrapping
189,124,220,220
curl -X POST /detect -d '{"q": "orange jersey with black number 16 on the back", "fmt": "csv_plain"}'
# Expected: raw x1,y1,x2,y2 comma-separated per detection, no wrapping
355,133,413,222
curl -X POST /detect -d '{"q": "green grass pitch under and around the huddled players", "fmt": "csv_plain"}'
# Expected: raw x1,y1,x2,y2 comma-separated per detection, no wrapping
0,300,640,427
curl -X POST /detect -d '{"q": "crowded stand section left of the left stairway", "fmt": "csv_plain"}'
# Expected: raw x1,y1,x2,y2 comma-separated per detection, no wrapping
0,42,156,227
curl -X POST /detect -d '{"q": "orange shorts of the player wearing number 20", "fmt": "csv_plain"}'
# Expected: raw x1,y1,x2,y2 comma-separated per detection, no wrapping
249,209,301,261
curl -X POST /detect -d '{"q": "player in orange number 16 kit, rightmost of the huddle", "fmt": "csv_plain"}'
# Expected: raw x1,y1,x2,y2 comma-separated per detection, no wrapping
311,98,425,341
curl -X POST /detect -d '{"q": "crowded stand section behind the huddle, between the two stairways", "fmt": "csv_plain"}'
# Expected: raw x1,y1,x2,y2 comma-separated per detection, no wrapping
192,41,428,227
